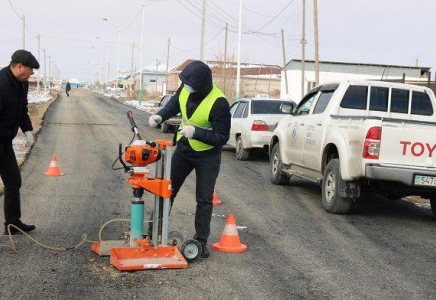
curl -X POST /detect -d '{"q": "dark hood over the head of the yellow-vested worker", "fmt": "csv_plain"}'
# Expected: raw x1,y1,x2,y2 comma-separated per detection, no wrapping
179,60,213,95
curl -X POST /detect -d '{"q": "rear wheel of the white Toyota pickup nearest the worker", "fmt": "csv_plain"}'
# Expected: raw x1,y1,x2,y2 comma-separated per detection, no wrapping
322,158,353,214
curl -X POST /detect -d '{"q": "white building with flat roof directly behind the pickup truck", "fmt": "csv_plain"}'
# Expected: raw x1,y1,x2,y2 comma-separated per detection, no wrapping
280,59,430,103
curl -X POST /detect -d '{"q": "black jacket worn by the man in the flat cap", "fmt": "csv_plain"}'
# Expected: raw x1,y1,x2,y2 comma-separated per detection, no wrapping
0,66,33,152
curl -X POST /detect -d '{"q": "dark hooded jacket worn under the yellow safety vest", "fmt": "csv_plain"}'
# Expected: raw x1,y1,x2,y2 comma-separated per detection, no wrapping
157,61,231,157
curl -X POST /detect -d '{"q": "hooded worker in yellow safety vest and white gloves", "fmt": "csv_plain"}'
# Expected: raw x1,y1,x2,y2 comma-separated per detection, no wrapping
149,61,231,258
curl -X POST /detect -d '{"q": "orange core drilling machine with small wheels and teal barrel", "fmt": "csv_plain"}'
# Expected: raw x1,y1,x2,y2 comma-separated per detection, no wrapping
92,111,201,271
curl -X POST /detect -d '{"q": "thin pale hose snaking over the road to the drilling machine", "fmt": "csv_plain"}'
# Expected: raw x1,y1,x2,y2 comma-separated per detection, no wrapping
0,219,153,253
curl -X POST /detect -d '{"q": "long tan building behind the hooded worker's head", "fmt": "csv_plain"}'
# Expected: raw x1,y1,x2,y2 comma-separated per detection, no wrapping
167,59,281,100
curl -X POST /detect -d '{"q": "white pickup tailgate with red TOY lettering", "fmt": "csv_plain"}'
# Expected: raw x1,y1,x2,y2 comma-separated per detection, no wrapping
379,123,436,168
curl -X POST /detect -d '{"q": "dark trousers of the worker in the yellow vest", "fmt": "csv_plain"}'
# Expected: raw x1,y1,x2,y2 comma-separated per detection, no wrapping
167,149,221,243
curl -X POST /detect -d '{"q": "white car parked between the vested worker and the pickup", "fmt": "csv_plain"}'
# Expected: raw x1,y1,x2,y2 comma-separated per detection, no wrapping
227,97,295,160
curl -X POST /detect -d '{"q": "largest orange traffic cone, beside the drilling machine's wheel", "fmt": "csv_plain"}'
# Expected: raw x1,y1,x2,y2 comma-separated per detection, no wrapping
212,214,247,253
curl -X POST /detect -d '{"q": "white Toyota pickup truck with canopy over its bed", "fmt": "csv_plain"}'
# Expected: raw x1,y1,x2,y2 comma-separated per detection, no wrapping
269,81,436,215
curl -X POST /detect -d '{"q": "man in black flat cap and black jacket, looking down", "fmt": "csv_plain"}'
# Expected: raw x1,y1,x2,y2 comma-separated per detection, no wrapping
0,50,39,234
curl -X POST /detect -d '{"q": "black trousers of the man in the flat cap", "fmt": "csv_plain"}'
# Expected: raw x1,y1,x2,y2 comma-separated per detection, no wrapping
0,142,21,225
